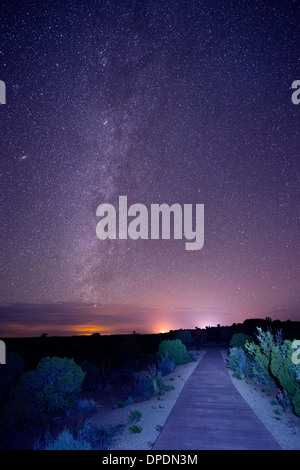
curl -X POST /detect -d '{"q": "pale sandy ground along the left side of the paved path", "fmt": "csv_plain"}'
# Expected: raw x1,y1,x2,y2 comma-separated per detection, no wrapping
85,351,205,450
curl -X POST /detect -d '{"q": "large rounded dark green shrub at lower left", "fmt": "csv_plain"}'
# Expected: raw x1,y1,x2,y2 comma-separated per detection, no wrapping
3,357,84,428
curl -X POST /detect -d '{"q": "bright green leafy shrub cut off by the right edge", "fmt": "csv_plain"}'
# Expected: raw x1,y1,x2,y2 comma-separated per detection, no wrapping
270,340,300,416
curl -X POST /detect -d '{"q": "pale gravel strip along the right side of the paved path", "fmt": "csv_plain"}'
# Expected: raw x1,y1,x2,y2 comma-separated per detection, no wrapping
222,350,300,450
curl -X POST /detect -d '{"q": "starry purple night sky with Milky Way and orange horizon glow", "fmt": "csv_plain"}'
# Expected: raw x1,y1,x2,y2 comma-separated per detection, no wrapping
0,0,300,336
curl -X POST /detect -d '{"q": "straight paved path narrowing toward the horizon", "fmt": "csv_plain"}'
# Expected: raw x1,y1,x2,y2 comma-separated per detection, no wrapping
153,347,281,450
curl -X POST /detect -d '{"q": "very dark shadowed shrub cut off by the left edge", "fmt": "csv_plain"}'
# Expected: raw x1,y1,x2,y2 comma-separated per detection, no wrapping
0,351,24,402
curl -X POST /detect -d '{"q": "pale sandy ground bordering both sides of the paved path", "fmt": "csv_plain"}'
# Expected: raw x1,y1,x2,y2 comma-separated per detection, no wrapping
89,349,300,450
